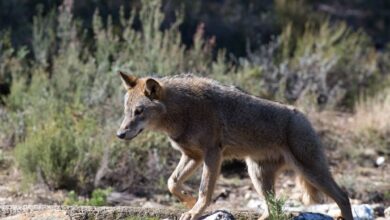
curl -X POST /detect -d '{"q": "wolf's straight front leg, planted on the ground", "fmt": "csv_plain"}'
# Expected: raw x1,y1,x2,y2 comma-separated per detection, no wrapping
180,148,222,220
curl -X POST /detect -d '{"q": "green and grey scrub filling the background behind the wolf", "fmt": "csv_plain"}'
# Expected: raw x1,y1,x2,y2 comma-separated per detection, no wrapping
0,0,390,203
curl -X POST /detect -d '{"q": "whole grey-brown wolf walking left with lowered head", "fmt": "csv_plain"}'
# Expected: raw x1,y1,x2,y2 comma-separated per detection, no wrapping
116,72,353,220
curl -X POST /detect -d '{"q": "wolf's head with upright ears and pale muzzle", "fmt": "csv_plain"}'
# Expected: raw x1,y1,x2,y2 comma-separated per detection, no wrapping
116,72,165,140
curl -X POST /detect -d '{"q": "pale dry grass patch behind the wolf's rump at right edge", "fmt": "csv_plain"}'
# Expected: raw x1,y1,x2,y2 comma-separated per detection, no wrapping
307,89,390,163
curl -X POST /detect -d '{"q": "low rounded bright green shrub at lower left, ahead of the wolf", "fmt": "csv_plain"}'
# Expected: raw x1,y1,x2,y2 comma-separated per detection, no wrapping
15,105,104,190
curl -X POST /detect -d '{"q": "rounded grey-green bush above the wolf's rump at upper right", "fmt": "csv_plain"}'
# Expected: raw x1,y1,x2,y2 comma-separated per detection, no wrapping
249,21,379,109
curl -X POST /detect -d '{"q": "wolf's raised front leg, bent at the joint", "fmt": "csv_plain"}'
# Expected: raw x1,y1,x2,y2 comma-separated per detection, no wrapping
168,154,202,208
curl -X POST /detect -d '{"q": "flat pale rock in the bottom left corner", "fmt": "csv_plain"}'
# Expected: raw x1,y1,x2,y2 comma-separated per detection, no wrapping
2,210,71,220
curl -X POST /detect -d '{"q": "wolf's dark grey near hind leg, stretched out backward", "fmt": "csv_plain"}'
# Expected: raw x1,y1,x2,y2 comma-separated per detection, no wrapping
285,111,353,220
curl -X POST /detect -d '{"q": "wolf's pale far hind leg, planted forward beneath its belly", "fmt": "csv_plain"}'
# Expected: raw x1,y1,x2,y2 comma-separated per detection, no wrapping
245,158,284,220
